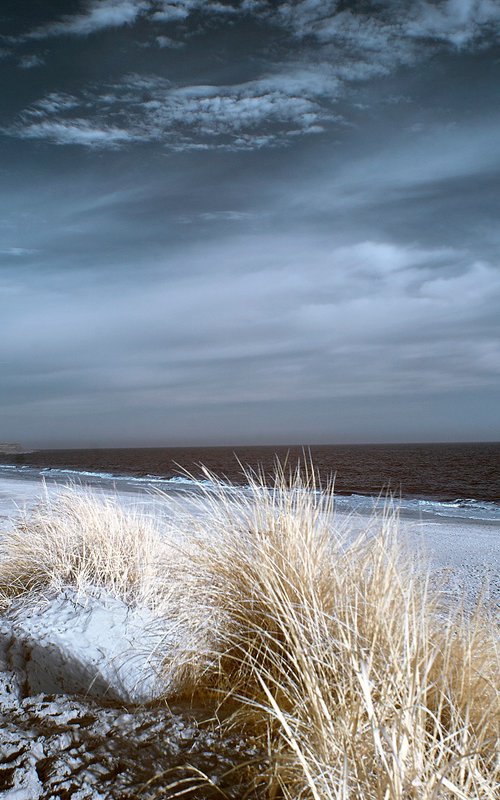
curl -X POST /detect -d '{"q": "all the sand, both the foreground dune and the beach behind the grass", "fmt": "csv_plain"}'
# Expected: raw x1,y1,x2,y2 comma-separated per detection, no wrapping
0,467,500,800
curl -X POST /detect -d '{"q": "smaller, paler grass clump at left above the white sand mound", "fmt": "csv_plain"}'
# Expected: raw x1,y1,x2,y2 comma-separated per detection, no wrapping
0,488,168,606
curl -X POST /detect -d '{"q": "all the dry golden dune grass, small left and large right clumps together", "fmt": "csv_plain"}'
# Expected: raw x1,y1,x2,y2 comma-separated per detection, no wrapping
0,472,499,800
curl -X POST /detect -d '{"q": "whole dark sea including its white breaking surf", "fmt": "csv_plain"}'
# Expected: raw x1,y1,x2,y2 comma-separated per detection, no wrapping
0,442,500,525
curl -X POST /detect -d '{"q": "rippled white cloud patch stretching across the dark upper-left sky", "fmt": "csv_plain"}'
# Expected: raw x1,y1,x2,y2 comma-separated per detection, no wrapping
8,69,339,150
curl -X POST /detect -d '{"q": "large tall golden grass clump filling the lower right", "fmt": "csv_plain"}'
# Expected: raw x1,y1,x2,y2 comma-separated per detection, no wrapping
169,472,499,800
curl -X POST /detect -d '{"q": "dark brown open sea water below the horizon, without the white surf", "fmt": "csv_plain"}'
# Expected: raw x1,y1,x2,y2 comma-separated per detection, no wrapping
0,443,500,503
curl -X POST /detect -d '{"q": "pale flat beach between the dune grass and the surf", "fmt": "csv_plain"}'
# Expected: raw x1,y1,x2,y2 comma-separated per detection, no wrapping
0,466,500,603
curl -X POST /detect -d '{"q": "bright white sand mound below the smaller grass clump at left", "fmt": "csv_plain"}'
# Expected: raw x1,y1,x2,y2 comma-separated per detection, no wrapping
0,589,170,703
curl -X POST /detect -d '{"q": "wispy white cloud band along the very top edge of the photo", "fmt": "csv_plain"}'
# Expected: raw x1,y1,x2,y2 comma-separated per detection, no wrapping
21,0,500,50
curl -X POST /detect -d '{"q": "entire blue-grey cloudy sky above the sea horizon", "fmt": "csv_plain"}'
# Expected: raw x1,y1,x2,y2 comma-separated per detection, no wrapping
0,0,500,447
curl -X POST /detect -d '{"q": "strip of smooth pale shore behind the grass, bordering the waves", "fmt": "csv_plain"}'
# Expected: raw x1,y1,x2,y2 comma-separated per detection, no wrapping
0,473,500,605
